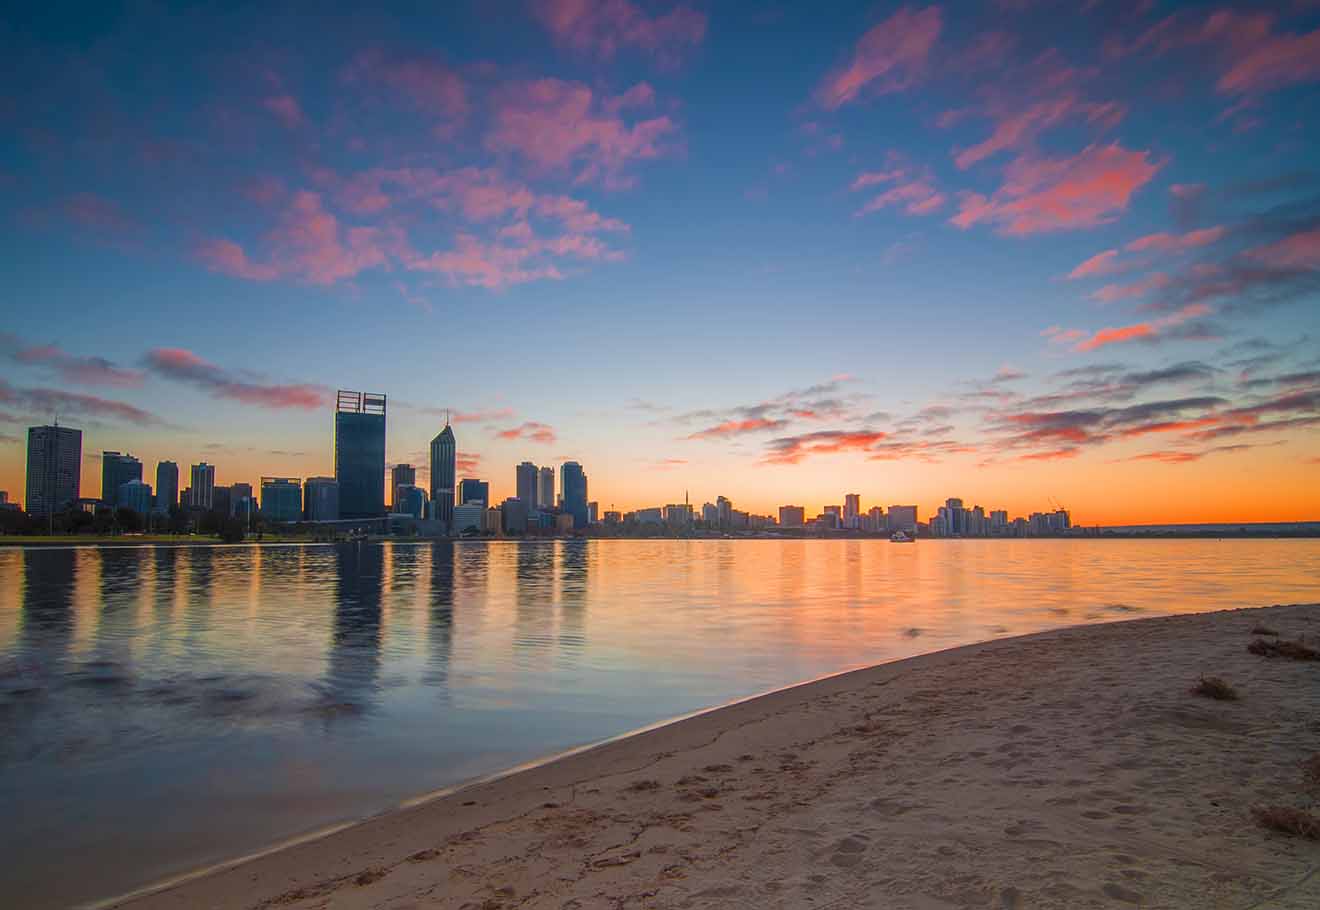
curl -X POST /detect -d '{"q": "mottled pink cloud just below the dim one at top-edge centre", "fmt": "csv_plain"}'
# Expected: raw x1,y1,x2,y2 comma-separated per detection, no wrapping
484,79,677,189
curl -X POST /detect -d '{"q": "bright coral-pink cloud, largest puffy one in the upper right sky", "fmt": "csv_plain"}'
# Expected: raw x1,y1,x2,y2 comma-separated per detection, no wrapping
950,143,1160,235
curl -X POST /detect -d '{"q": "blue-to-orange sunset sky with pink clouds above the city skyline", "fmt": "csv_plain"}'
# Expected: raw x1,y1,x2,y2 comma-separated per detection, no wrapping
0,0,1320,524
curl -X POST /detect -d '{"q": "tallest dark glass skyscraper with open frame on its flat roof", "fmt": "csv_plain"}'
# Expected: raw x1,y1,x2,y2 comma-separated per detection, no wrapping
334,390,385,518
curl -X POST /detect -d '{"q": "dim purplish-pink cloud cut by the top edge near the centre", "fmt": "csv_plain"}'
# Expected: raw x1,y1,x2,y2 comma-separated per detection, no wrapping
532,0,706,65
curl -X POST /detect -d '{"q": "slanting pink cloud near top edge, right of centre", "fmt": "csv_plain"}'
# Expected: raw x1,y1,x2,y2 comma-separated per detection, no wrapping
816,7,942,110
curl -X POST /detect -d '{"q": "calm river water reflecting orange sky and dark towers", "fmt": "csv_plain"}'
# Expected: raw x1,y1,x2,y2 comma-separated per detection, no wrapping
0,540,1320,906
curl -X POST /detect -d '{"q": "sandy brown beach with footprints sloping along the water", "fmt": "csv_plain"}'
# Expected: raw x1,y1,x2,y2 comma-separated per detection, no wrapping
105,605,1320,910
